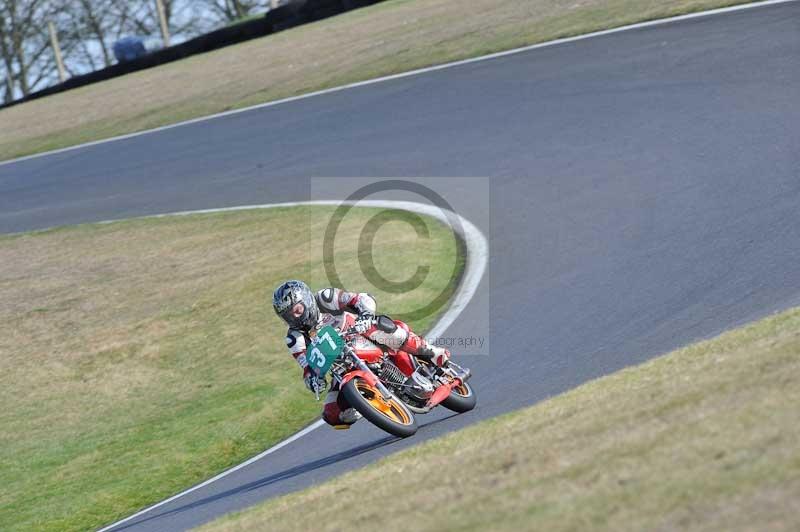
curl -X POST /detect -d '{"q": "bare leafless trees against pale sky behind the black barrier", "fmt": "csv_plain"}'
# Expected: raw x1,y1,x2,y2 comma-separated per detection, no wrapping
0,0,271,102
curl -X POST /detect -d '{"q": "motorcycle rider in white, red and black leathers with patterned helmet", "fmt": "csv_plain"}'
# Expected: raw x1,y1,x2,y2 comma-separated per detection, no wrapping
272,281,450,428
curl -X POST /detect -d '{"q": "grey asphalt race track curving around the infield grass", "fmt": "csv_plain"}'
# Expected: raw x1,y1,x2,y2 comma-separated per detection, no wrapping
0,2,800,530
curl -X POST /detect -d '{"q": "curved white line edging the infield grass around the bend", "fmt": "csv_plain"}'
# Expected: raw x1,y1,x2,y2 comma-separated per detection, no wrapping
98,200,489,532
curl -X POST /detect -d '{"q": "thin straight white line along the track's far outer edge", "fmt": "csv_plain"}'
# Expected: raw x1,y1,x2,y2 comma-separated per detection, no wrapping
0,0,798,166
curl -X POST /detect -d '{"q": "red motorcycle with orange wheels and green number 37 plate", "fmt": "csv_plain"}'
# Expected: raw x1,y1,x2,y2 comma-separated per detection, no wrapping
306,313,477,438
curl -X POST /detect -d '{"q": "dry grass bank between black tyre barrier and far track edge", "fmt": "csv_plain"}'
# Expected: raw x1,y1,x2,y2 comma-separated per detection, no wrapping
0,0,760,159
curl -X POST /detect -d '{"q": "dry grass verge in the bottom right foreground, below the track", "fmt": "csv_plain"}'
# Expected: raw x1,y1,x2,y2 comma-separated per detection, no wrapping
202,309,800,532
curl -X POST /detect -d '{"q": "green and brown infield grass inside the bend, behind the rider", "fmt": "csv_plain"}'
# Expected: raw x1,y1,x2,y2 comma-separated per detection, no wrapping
0,207,461,531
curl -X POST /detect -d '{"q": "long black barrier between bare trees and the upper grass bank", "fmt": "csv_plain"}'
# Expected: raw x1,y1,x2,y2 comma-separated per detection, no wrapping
0,0,383,109
